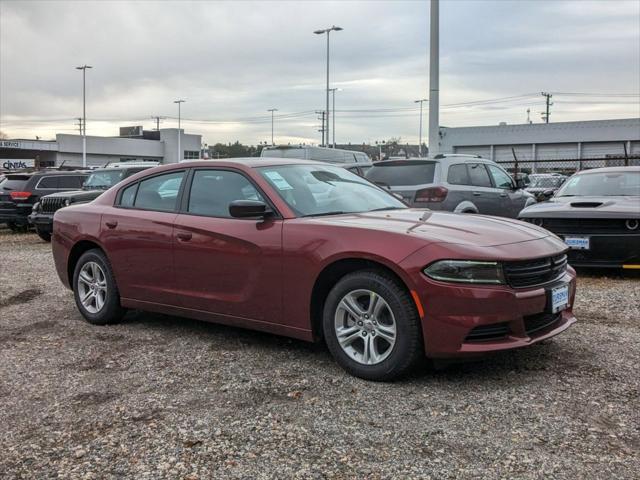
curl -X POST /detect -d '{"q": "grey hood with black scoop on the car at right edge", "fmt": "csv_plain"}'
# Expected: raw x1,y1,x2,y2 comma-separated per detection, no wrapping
520,196,640,218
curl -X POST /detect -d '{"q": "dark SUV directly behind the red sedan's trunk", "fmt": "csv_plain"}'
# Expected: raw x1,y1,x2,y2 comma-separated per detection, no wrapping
29,164,150,242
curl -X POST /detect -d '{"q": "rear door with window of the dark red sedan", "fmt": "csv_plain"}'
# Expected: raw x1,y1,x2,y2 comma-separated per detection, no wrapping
100,170,186,305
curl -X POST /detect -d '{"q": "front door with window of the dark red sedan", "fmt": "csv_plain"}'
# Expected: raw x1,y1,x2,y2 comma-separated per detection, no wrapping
173,169,282,323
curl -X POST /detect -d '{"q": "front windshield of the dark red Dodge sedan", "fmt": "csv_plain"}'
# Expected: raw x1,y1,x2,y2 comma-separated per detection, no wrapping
258,165,407,217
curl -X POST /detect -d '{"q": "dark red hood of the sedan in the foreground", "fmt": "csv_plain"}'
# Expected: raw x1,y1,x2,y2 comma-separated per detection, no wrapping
305,208,552,247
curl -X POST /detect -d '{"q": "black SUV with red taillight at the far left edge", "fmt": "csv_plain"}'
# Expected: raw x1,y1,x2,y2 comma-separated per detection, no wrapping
0,170,89,231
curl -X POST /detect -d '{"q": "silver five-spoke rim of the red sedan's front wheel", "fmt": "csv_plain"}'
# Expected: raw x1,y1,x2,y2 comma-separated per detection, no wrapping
334,289,396,365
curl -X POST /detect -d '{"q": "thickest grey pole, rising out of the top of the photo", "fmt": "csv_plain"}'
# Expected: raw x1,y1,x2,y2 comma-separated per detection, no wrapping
429,0,440,156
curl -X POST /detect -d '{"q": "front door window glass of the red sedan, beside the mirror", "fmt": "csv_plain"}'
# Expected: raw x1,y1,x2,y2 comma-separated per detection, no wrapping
187,170,264,218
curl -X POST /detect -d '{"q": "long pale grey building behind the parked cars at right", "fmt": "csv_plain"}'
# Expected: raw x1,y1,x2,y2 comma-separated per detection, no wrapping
439,118,640,169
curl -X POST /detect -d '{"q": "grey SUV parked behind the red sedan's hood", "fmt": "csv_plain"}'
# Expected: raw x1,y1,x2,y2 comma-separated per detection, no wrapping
365,154,535,218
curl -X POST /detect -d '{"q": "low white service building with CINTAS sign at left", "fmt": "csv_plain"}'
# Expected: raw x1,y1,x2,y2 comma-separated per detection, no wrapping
0,128,202,169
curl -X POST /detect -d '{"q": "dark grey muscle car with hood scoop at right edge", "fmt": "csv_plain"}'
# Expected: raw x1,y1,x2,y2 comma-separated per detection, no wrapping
520,167,640,269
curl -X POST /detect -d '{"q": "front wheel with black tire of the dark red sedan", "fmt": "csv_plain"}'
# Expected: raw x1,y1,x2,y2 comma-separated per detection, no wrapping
322,270,424,381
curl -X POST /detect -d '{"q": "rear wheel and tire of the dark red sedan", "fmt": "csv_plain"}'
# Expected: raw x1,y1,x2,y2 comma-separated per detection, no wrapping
73,249,126,325
